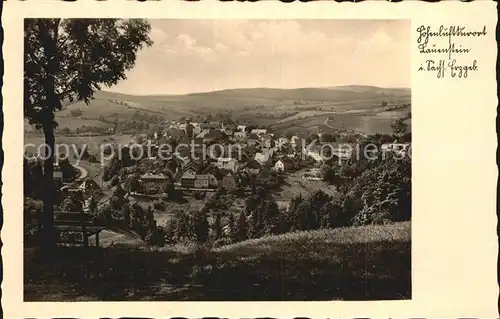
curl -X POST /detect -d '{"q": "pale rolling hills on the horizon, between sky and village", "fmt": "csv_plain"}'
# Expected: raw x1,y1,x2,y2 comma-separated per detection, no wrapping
25,85,411,135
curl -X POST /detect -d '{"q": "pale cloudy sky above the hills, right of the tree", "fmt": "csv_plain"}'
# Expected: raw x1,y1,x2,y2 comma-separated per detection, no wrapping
108,19,410,95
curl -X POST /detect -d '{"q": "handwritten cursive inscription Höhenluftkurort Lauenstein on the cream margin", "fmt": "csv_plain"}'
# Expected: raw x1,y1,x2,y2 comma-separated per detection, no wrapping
417,25,487,79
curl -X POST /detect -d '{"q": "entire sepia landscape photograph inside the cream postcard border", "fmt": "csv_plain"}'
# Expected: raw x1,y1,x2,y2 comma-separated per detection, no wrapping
23,18,412,302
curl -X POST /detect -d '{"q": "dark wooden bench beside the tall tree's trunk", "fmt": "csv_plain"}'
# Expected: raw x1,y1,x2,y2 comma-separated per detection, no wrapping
30,211,106,247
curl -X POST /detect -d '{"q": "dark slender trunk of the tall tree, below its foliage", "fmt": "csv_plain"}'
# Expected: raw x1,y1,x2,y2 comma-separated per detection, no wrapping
42,122,56,247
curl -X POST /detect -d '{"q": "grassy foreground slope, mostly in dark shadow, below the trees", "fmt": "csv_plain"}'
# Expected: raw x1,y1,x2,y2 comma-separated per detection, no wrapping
24,222,411,301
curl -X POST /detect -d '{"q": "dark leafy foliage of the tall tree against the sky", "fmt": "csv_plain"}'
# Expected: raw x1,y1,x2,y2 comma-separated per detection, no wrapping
24,19,152,128
